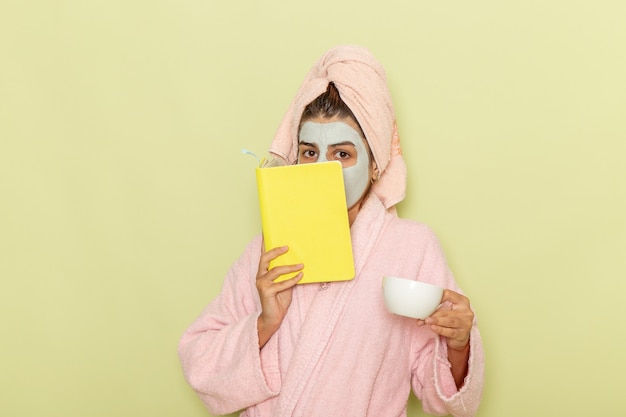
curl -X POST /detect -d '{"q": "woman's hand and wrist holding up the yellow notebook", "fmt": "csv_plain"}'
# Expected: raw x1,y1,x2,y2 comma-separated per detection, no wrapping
256,246,304,348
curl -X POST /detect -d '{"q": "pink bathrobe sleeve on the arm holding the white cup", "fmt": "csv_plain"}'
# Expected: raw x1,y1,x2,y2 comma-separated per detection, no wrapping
412,226,484,417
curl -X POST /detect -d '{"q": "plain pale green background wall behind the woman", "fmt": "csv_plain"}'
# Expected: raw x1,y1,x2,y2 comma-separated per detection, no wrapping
0,0,626,417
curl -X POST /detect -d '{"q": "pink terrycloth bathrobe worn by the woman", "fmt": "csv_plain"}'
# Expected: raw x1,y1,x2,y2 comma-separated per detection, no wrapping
179,195,483,417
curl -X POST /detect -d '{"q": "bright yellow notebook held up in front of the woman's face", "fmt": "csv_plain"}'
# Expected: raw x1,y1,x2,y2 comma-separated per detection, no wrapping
256,161,354,284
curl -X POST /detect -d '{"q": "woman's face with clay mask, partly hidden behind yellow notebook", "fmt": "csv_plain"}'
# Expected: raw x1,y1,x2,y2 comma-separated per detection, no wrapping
298,117,375,208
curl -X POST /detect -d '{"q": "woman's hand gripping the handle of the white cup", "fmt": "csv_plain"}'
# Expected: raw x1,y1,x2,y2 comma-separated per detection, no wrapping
418,290,474,350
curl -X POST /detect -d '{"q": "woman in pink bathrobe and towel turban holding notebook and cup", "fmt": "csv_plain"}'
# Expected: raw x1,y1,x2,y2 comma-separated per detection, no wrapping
179,46,483,417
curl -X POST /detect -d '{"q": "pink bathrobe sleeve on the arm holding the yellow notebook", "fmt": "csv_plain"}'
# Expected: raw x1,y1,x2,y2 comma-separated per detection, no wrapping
178,237,280,414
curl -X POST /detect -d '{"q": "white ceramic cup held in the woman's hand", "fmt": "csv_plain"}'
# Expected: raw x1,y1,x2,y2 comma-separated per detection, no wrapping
383,276,443,320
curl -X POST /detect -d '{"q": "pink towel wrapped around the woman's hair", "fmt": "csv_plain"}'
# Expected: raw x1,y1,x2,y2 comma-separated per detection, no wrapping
270,46,406,208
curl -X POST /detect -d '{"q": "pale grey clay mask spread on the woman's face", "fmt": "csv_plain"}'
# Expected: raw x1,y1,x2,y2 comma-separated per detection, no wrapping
299,122,370,208
